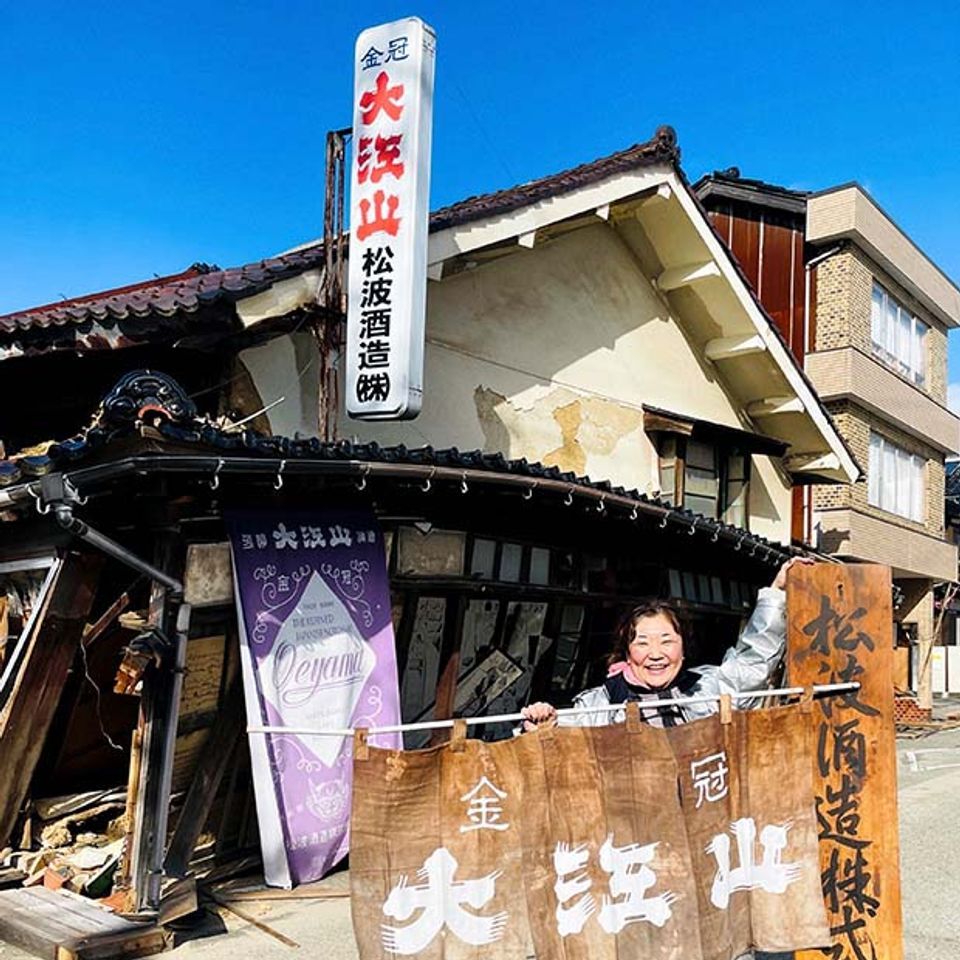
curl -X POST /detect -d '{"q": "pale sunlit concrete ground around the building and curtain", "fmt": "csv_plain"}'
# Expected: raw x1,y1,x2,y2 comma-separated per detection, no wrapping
0,701,960,960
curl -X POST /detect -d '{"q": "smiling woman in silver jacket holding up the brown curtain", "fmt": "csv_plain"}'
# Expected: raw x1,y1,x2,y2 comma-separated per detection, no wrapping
522,557,813,731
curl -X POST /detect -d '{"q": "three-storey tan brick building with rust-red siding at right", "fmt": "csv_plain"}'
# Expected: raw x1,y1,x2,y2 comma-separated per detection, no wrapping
694,169,960,707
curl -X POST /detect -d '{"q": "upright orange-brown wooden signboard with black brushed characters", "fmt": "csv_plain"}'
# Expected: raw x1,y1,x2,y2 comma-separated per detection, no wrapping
787,563,903,960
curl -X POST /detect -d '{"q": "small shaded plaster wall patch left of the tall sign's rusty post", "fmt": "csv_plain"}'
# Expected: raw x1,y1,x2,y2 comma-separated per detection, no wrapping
240,333,320,437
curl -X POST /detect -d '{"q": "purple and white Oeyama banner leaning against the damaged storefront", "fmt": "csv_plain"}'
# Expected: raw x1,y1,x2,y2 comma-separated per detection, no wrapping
226,509,402,887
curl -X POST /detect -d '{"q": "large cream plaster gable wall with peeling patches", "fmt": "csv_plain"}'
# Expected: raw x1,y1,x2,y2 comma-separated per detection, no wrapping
322,224,790,540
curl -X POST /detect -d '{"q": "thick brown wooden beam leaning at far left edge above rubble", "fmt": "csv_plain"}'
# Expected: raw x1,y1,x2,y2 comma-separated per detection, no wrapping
0,553,103,846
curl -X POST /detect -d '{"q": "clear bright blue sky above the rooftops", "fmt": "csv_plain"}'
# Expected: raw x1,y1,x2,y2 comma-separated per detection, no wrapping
0,0,960,382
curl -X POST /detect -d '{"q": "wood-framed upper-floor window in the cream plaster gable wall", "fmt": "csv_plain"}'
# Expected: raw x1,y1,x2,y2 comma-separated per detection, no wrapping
659,434,750,528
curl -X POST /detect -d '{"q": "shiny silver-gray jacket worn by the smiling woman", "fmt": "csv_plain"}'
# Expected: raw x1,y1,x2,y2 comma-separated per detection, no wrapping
558,587,787,727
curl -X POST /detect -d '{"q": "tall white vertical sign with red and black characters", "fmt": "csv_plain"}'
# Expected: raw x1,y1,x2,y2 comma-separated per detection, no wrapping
346,17,436,420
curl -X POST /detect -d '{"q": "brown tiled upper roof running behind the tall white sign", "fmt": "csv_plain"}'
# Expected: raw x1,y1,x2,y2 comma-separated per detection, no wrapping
0,127,680,344
